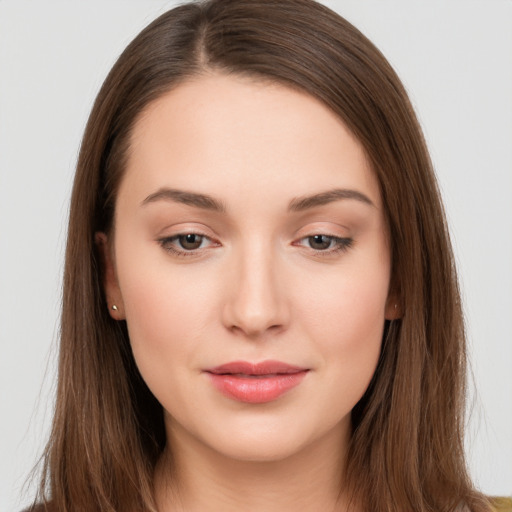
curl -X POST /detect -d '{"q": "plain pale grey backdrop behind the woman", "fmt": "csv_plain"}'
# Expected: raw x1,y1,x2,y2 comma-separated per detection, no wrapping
0,0,512,512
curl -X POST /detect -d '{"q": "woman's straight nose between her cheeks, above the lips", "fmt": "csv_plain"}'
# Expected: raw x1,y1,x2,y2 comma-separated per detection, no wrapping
223,244,290,338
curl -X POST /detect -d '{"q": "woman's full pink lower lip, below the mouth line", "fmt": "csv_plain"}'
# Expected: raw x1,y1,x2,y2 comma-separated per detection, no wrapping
208,370,307,404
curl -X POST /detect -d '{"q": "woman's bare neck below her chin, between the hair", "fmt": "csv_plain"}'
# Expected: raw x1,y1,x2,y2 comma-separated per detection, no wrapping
155,420,356,512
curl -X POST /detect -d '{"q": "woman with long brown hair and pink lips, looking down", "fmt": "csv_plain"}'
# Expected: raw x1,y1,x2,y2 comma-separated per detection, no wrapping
27,0,508,512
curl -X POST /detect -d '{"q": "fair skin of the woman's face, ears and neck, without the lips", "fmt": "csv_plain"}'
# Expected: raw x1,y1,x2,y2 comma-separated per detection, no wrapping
97,74,396,512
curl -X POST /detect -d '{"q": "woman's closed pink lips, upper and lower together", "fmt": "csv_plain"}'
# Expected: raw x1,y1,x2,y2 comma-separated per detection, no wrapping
205,361,309,404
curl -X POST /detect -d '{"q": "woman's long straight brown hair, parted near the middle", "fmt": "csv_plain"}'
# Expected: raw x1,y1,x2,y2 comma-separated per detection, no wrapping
35,0,489,512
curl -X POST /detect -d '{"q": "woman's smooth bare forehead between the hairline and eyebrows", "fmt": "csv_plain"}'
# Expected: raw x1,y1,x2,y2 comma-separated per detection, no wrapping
122,74,380,210
